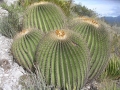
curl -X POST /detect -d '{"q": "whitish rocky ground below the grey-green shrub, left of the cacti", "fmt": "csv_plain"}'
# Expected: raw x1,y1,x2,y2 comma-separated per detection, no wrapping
0,34,25,90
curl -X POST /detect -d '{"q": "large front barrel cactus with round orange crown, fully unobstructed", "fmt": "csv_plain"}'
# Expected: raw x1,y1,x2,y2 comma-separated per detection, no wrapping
36,30,89,90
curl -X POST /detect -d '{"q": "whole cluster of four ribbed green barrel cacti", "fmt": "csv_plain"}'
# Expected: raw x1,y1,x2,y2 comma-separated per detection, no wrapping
12,2,109,90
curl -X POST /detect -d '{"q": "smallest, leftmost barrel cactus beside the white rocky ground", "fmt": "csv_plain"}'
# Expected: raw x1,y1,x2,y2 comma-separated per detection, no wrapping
12,29,42,71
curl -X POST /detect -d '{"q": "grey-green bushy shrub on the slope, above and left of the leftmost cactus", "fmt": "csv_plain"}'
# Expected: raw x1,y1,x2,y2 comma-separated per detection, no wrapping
0,3,22,38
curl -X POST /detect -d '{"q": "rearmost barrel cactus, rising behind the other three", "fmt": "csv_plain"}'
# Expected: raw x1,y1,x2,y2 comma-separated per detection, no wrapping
24,2,66,32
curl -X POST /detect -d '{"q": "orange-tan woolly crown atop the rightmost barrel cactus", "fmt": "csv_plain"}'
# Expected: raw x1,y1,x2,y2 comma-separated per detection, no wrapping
76,17,100,28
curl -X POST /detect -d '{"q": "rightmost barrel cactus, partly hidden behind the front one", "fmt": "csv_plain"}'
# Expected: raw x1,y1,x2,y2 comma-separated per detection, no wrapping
70,17,109,81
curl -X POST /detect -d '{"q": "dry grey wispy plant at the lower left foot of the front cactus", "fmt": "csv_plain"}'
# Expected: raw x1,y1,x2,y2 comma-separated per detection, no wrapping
19,67,53,90
